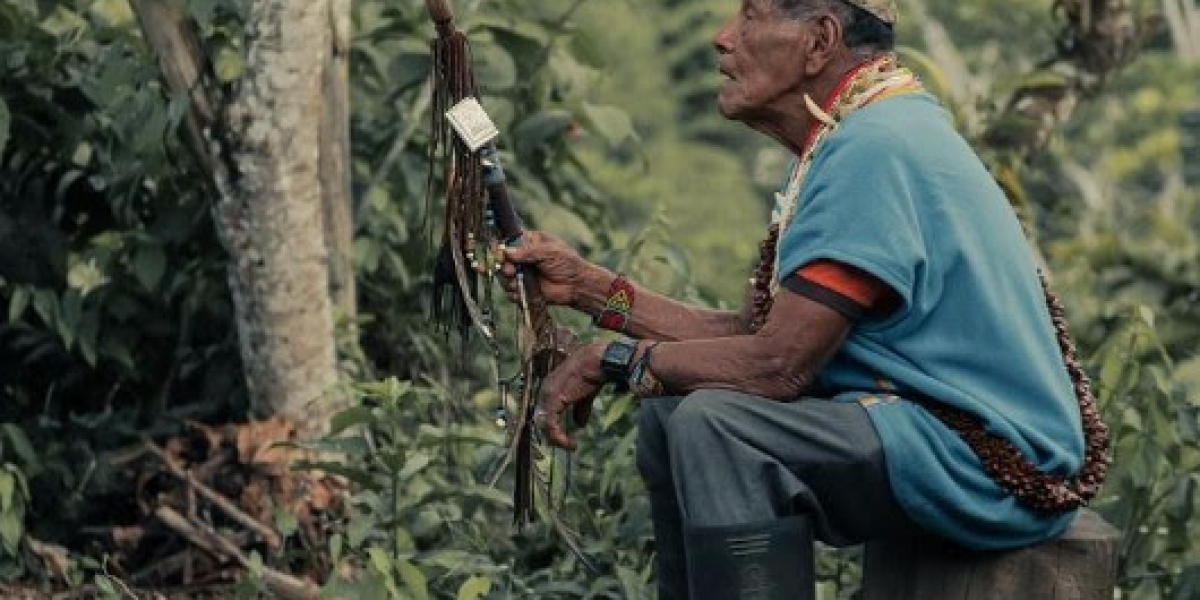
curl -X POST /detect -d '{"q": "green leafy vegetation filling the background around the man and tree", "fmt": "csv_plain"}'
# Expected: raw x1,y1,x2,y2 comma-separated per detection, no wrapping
0,0,1200,600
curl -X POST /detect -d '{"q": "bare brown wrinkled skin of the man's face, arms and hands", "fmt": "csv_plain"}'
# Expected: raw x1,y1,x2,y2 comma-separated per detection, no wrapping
503,0,862,448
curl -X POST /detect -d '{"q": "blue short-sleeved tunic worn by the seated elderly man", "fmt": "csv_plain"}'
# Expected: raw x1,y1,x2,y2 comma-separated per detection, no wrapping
779,94,1084,548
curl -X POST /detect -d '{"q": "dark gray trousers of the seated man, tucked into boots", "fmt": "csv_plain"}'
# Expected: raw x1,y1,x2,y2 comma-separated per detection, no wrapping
637,390,917,600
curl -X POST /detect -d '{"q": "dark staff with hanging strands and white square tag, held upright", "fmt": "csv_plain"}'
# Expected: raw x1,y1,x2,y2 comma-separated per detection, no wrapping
426,0,590,564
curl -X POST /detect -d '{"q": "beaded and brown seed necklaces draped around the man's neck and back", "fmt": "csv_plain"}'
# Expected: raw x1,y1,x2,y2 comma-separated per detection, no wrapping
750,55,1109,512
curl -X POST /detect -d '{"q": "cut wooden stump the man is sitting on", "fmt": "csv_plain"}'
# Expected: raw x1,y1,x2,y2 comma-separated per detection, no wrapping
863,510,1120,600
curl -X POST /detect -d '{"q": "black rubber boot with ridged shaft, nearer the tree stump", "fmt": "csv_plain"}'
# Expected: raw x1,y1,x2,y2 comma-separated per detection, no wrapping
686,516,816,600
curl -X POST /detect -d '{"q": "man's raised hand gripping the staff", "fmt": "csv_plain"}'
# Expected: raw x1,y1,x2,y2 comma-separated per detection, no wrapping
502,232,599,306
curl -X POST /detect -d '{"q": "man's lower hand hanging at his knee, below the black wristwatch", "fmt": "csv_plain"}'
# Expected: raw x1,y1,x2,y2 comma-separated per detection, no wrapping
534,343,605,449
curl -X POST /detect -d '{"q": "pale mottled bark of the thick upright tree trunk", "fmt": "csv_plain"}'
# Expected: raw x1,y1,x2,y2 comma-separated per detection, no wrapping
215,0,337,428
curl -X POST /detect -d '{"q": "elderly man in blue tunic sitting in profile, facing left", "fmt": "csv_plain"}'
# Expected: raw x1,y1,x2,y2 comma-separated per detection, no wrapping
496,0,1097,600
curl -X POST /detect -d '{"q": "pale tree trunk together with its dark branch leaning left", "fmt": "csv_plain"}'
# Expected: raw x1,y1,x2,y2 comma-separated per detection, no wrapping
132,0,354,437
